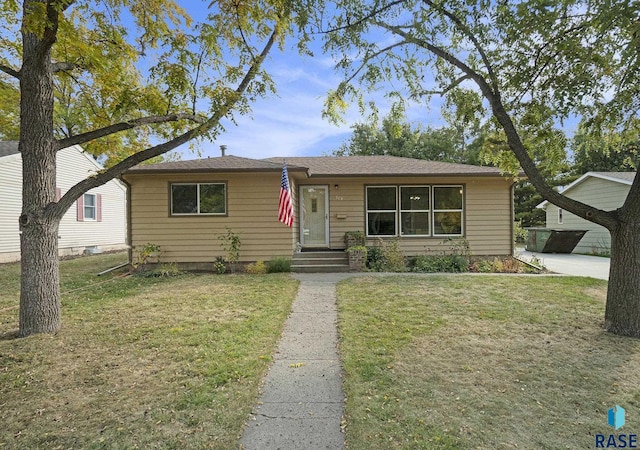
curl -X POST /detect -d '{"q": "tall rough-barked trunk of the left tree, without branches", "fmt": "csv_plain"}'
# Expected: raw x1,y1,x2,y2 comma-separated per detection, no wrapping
19,0,60,336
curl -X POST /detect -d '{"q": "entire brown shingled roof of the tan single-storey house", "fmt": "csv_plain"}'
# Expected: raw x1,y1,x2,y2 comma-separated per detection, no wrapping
126,155,501,177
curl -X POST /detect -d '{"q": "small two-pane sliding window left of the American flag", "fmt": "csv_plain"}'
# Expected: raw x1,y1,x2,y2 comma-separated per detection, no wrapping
171,183,227,216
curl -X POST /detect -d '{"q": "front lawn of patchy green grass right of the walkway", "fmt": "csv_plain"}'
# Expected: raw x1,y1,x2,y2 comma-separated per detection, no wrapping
338,275,640,449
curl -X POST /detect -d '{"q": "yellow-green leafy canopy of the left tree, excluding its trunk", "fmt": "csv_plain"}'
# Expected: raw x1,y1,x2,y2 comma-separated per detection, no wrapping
0,0,291,166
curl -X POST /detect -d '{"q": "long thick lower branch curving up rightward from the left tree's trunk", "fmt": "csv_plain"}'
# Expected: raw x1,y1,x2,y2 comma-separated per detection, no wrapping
47,24,280,219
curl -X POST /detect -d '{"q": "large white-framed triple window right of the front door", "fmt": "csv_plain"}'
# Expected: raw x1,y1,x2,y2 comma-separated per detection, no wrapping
366,185,464,237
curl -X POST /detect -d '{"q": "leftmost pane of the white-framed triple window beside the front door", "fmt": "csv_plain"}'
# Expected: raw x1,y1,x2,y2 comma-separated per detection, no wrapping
366,186,398,236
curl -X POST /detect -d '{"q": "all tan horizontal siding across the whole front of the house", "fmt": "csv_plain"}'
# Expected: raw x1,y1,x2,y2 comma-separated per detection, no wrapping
127,173,512,262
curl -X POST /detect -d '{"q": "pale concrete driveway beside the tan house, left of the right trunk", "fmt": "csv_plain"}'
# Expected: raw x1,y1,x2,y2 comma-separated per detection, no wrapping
516,249,610,280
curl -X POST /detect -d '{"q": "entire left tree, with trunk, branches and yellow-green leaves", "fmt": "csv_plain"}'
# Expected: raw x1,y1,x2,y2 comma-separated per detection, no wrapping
0,0,304,336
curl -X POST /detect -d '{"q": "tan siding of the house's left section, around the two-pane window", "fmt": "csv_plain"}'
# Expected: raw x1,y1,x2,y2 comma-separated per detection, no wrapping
127,173,293,262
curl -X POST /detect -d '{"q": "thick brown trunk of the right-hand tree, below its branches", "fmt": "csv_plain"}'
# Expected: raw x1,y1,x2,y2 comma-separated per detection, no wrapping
604,220,640,337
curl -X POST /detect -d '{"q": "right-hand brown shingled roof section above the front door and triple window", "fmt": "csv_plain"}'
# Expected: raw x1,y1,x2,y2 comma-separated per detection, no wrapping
266,156,500,177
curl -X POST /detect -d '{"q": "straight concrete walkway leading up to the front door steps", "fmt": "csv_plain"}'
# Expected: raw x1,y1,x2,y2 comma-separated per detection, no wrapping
240,274,353,450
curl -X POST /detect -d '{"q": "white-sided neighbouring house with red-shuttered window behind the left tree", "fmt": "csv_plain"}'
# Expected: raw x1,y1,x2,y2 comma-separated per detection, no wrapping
0,141,127,263
